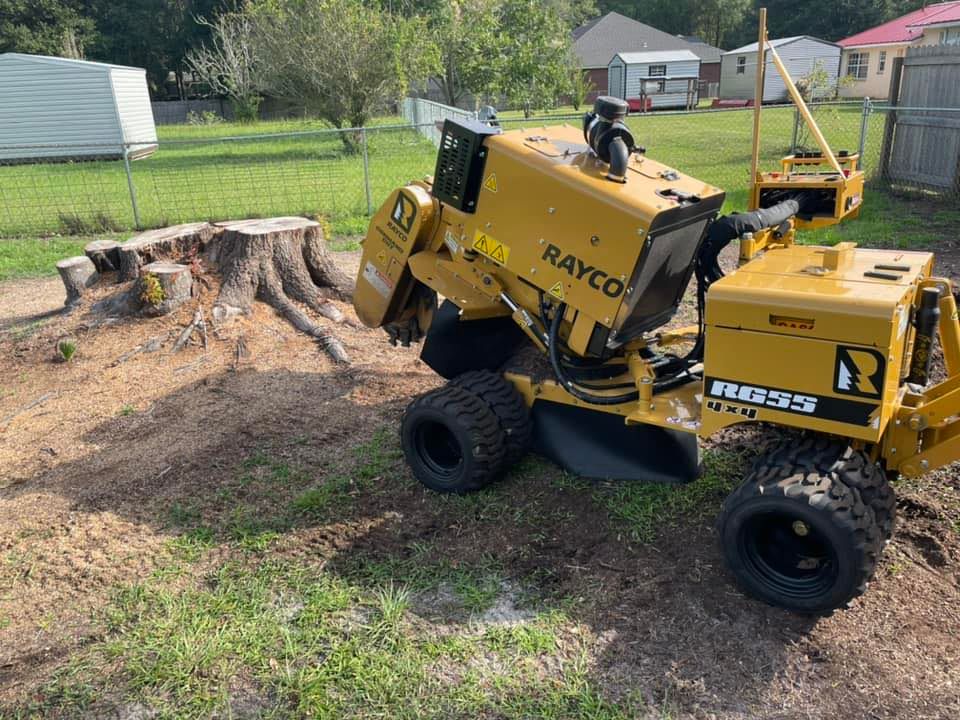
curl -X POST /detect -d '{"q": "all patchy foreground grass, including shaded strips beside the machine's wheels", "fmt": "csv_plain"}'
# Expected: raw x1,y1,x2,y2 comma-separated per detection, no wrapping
0,420,736,720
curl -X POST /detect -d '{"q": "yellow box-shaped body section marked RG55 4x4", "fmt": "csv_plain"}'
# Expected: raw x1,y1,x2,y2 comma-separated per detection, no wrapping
701,246,933,442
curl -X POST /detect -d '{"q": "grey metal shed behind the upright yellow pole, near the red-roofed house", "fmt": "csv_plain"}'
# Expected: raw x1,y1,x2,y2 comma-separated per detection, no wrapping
720,35,841,103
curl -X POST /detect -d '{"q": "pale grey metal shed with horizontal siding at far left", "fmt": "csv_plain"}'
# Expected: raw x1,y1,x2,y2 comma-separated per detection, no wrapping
0,53,157,161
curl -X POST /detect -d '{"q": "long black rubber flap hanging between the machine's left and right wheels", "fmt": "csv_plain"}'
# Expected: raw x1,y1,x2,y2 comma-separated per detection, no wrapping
531,400,701,483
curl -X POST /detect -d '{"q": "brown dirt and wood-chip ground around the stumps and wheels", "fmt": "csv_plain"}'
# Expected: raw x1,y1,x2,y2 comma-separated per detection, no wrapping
0,248,960,720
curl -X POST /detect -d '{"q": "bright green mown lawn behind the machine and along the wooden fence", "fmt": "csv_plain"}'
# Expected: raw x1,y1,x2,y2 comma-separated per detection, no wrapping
0,104,957,280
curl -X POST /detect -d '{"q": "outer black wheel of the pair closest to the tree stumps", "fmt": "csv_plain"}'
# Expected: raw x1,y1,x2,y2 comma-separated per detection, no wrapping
400,385,506,493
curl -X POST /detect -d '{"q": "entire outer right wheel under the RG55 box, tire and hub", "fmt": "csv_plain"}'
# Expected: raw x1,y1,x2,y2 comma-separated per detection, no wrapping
718,437,882,614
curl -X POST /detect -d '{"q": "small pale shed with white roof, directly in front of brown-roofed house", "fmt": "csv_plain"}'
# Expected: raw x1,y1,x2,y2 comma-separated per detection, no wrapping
607,50,700,109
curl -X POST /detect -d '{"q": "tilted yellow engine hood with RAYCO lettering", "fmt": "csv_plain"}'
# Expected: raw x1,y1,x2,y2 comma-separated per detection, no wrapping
434,125,724,356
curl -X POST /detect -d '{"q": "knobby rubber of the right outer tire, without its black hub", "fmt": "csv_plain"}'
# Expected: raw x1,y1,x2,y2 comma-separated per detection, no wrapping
717,436,886,615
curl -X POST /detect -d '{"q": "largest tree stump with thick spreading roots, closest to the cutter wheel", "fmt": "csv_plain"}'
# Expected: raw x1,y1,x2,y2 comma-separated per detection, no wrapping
213,217,351,363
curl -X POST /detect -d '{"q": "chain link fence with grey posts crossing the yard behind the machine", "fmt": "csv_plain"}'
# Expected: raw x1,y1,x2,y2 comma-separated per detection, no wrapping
0,99,944,237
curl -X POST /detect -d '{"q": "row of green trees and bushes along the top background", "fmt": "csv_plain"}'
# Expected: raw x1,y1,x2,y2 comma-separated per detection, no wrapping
0,0,924,119
